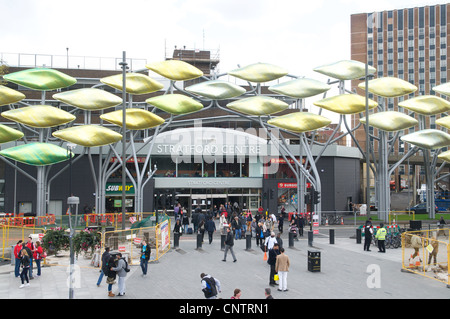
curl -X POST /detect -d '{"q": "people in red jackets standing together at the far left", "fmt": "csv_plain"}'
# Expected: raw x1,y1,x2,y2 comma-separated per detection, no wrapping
13,236,45,288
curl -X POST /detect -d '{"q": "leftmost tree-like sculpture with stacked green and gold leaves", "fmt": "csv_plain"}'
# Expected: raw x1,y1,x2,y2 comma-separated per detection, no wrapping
0,68,76,216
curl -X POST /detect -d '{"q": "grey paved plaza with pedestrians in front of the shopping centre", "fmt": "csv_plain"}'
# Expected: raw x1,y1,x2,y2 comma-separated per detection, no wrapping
0,221,450,300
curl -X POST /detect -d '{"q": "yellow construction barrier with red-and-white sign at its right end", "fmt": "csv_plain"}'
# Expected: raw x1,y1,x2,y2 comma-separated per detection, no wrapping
101,219,171,265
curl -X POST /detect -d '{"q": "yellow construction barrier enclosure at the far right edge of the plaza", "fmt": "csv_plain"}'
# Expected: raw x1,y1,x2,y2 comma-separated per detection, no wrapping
402,228,450,288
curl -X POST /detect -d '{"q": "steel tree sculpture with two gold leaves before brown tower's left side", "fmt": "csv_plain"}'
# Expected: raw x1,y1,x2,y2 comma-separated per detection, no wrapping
358,77,418,221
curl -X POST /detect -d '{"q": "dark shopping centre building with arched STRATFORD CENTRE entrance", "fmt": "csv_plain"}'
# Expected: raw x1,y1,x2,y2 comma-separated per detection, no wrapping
0,50,362,220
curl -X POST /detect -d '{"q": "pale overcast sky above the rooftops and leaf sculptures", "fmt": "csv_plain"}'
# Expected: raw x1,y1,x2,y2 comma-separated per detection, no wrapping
0,0,447,124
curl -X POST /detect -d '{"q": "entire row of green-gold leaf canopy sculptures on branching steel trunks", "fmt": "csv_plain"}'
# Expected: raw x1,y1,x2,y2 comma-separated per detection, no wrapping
0,52,450,224
